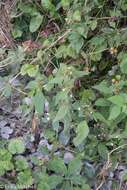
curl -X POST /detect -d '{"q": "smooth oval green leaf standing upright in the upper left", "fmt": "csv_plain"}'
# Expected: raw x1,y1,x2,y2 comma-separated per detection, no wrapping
29,14,43,33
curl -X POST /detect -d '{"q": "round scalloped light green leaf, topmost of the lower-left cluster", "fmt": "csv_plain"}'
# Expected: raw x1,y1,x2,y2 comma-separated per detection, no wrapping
8,138,25,154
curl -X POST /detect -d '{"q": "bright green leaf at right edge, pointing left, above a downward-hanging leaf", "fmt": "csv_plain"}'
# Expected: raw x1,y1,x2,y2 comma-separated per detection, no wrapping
108,95,125,107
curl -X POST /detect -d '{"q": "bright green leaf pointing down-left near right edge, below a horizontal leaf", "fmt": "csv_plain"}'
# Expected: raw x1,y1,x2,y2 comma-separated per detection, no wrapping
109,105,121,120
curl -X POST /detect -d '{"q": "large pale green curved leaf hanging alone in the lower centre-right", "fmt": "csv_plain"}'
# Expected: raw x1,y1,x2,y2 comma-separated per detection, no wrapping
73,121,89,146
